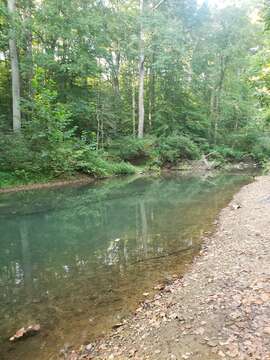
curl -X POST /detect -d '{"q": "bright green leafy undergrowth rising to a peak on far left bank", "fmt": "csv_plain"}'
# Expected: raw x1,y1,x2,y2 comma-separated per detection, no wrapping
0,72,135,184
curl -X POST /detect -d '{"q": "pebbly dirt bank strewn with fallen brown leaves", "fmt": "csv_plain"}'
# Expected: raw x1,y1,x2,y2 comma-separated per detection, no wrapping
69,177,270,360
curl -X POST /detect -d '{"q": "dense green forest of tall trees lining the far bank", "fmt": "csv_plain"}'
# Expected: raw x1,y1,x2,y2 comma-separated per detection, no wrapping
0,0,270,187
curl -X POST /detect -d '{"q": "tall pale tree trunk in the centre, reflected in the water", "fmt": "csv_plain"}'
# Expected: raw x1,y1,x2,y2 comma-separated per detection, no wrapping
138,0,145,138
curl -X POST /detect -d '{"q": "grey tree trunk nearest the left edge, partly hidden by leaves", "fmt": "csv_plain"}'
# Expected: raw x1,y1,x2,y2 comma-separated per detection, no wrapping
7,0,21,132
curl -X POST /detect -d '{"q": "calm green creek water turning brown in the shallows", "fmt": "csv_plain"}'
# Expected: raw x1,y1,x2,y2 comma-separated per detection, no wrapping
0,174,251,360
